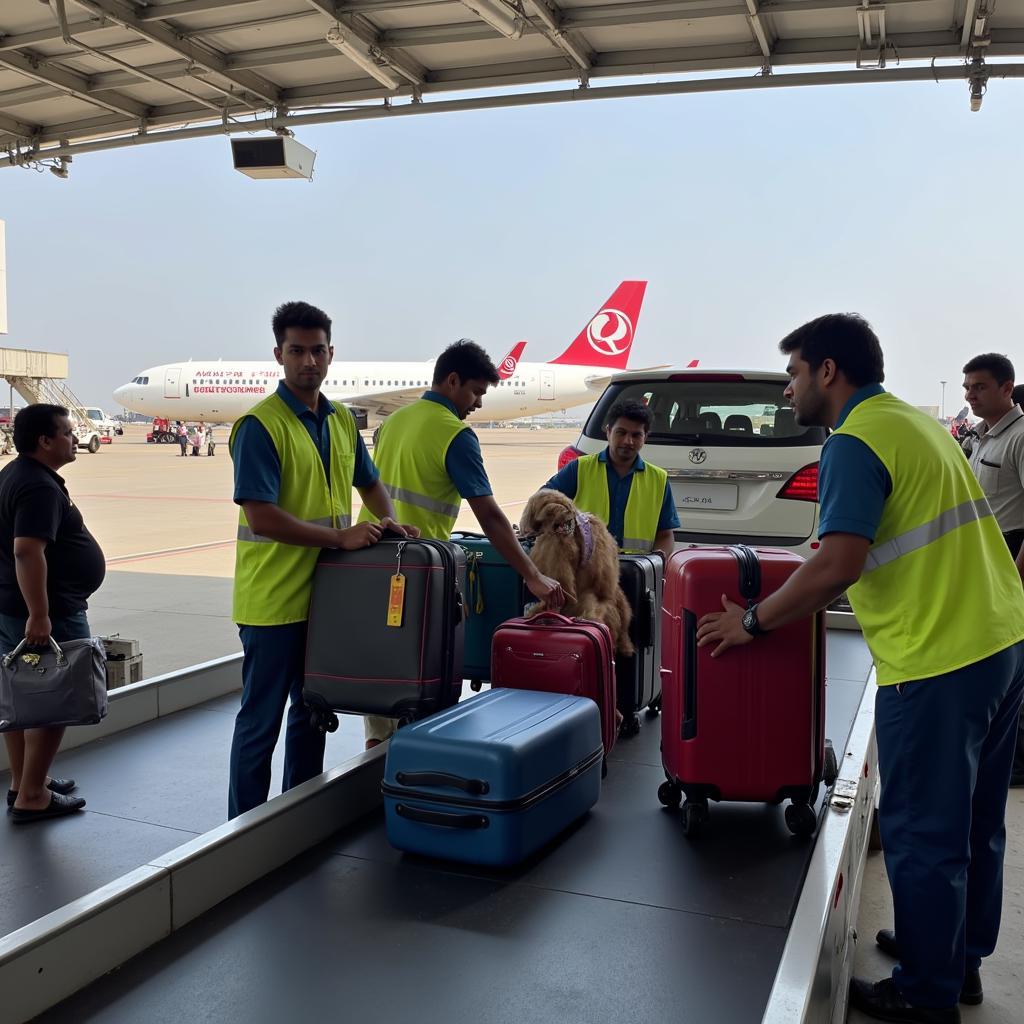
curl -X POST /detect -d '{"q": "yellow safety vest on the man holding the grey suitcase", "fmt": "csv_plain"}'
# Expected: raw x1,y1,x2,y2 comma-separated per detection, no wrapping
227,394,358,626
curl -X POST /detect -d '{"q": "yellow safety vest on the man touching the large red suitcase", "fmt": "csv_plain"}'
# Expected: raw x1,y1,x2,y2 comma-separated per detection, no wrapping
825,393,1024,686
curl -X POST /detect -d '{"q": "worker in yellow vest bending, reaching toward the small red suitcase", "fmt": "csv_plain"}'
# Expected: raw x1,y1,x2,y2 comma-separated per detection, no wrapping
359,338,565,749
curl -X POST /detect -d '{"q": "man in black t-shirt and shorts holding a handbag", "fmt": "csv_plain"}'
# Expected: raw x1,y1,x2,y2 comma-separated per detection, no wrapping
0,404,106,822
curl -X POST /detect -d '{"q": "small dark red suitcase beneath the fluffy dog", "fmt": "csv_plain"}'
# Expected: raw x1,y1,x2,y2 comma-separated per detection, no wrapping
490,611,617,755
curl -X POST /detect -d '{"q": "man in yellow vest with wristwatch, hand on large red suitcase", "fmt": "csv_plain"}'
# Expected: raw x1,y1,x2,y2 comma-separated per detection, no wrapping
697,313,1024,1024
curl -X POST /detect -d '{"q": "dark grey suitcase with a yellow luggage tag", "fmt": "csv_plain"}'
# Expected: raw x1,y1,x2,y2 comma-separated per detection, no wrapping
303,537,466,731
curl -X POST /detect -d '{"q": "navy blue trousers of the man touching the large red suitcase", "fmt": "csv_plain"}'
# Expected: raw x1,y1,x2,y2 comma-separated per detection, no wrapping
874,641,1024,1007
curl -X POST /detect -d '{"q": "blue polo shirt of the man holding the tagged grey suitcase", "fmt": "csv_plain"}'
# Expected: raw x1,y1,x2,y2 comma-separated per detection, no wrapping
231,381,380,505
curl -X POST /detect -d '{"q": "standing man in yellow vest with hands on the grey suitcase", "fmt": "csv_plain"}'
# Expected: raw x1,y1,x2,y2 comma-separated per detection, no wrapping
227,302,416,817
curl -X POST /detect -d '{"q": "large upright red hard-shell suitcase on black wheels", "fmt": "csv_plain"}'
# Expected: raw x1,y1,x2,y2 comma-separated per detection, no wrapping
658,545,836,836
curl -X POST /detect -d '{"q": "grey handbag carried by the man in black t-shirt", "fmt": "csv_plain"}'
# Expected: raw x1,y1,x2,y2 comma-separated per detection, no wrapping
0,637,106,732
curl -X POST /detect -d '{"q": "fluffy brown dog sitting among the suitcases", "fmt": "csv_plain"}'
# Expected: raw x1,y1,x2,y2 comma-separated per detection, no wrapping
519,488,635,654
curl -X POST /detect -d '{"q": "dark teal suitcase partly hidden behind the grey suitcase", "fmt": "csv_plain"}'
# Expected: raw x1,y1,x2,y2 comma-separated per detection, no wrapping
452,531,532,690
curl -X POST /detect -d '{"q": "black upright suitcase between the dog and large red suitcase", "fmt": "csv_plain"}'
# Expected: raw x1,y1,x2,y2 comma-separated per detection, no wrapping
615,554,665,736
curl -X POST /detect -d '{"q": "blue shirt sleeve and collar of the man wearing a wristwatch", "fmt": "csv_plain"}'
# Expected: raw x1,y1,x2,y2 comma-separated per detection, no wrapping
818,384,893,541
